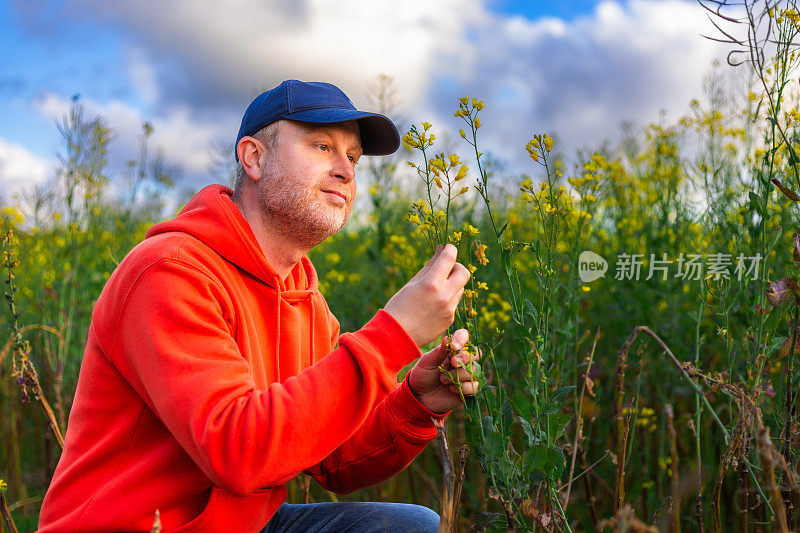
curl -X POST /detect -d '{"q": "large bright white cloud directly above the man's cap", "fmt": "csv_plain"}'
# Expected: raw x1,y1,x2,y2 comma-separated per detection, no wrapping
67,0,484,109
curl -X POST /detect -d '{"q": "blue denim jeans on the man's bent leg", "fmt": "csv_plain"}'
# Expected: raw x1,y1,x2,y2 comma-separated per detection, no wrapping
261,502,439,533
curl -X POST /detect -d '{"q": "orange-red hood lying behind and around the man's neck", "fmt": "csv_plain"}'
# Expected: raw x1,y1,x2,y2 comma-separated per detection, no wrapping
145,185,317,290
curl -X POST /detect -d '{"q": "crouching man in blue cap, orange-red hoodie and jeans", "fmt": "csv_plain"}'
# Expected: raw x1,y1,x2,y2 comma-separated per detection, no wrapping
40,80,477,532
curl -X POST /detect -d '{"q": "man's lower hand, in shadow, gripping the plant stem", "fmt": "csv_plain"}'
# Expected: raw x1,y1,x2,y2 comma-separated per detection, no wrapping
408,329,479,413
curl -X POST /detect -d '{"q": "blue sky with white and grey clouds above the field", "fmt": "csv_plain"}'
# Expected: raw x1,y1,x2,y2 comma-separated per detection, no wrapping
0,0,726,198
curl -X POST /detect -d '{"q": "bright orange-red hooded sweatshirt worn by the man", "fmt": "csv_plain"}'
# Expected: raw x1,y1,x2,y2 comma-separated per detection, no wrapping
39,185,438,533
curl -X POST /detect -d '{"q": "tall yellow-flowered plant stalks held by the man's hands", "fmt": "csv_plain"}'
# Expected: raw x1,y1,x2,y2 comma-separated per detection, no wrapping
404,96,574,531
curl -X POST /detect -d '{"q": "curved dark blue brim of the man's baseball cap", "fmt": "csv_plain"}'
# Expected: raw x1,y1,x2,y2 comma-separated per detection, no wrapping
282,108,400,155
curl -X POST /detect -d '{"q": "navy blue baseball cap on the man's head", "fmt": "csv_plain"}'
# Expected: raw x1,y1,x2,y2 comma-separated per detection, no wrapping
233,80,400,161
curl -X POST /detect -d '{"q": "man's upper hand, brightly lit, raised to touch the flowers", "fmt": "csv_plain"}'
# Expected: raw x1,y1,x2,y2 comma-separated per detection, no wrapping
384,244,470,347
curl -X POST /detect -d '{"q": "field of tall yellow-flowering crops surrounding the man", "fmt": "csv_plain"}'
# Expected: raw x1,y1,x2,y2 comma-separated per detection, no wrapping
0,2,800,531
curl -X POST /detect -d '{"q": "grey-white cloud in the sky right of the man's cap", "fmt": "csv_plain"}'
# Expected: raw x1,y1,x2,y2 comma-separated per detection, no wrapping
425,0,726,168
